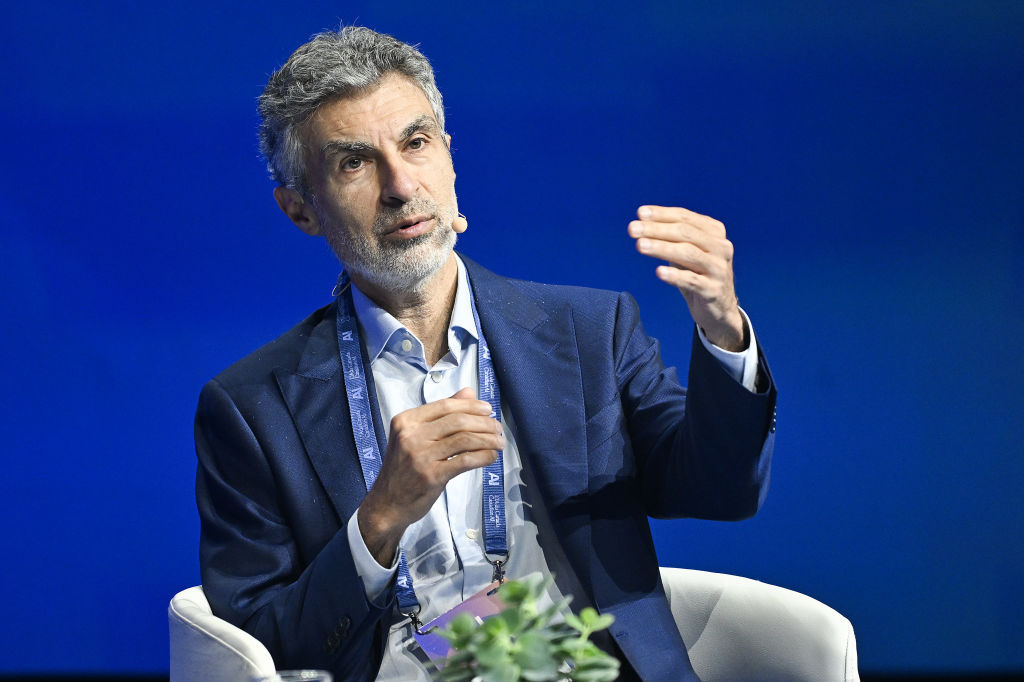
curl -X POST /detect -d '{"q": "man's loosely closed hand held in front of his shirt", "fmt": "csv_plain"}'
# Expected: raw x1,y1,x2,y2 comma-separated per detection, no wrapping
358,388,505,566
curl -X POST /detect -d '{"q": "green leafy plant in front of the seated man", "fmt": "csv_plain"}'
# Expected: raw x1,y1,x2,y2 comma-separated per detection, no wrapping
436,578,618,682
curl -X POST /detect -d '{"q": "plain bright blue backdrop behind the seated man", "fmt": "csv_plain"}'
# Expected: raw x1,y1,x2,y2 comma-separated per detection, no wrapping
0,2,1024,672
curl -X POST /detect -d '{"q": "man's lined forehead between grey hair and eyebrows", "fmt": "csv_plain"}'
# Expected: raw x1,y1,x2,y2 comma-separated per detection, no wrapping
306,74,434,150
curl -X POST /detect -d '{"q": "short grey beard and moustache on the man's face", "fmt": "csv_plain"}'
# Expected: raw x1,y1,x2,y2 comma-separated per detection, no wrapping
321,193,458,292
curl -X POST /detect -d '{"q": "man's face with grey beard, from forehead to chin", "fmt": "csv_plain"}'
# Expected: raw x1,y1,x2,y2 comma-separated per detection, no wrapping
304,74,458,291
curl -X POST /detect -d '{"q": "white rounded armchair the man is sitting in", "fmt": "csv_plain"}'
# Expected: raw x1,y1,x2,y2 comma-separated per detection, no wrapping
167,568,859,682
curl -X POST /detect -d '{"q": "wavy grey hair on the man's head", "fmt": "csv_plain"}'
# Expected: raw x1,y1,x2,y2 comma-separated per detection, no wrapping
259,26,444,194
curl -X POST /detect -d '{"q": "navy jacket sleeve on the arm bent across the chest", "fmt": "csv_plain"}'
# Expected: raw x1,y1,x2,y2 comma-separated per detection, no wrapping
196,380,394,680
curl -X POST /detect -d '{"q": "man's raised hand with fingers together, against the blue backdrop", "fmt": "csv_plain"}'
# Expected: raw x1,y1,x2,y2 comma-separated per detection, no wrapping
630,206,750,351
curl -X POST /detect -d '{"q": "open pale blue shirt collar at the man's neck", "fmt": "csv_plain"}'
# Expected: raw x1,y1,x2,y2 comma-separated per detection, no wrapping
351,254,477,364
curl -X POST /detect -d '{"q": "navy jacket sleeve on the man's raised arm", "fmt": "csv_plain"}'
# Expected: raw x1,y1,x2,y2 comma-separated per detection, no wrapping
613,294,776,520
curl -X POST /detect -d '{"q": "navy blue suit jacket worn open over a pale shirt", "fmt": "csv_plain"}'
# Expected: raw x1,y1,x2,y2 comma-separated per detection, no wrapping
196,259,775,680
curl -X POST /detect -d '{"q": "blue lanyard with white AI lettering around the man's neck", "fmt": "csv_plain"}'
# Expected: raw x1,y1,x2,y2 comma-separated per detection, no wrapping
335,272,508,628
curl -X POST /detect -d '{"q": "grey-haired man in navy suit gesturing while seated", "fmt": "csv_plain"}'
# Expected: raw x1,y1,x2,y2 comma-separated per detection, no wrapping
196,27,775,680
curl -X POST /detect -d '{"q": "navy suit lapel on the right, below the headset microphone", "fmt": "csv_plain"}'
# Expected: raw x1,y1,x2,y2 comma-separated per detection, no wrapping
463,256,592,590
